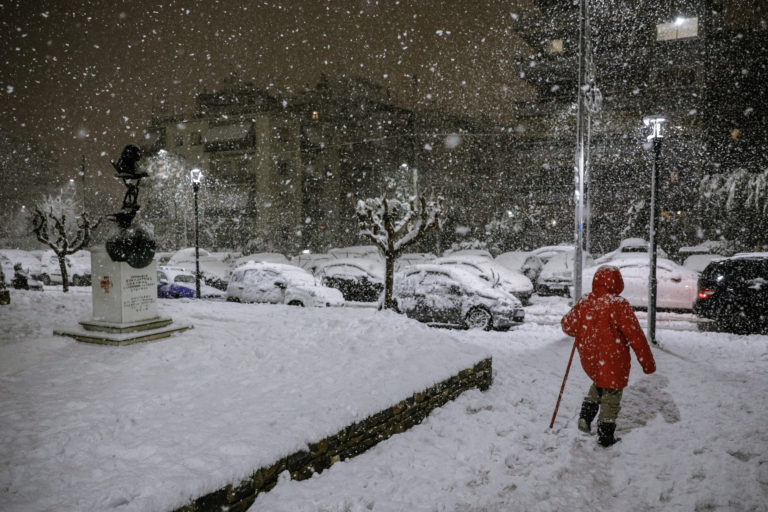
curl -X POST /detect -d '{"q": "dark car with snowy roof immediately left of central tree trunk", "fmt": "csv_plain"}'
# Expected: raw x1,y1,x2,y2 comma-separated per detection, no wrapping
317,258,384,302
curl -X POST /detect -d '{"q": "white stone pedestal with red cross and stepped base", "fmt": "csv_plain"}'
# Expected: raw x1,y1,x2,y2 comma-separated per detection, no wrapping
54,247,192,345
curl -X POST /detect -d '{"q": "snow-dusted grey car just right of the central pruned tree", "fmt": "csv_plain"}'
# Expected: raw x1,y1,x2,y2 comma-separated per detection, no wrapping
393,264,525,330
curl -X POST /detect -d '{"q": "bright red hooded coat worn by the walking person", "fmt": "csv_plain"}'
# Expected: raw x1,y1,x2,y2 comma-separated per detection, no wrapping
560,266,656,389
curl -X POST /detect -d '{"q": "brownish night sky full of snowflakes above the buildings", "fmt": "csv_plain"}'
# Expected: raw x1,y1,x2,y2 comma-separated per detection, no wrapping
0,0,530,204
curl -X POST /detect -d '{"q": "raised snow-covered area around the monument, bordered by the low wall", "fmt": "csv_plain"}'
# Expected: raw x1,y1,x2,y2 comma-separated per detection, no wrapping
0,291,489,512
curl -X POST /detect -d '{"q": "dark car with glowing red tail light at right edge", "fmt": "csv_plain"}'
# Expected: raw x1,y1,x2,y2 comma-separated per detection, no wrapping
693,253,768,333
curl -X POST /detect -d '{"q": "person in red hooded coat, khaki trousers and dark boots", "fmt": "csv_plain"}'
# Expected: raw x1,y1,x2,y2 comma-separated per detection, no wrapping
560,266,656,446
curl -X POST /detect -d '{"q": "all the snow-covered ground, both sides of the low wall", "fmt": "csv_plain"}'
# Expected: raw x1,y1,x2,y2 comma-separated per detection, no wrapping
0,290,768,512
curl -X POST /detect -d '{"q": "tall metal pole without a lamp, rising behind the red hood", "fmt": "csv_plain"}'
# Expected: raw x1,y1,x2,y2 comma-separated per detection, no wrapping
573,0,587,301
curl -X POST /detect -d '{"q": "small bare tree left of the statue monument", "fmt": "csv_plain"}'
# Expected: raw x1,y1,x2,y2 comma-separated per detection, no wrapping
32,197,101,292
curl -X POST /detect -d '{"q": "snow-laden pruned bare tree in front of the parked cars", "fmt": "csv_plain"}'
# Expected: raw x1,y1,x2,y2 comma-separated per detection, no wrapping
357,196,444,309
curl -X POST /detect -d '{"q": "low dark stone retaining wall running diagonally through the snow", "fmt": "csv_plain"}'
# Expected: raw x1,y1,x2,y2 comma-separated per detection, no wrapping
174,358,493,512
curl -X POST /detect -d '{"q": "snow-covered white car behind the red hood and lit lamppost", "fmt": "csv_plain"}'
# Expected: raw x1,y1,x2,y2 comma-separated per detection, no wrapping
582,257,698,311
